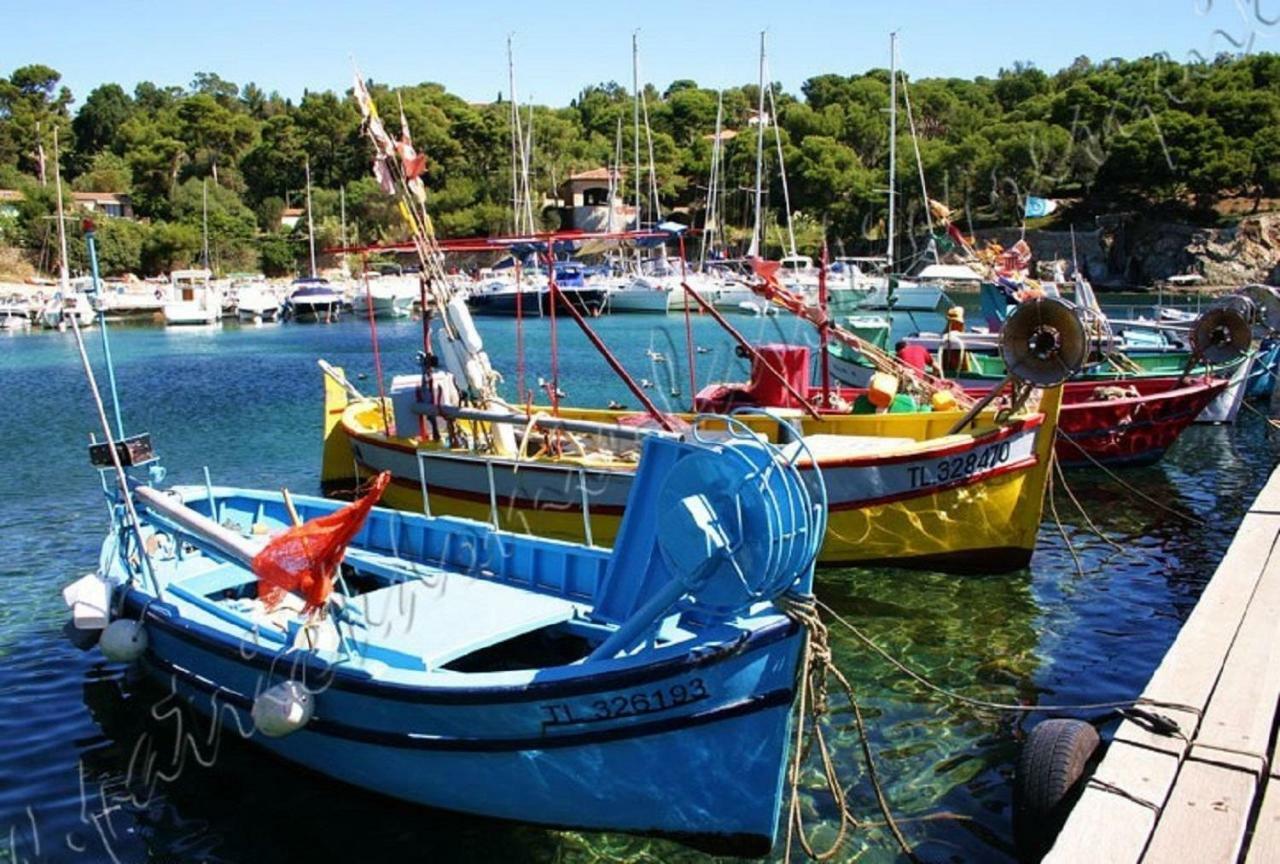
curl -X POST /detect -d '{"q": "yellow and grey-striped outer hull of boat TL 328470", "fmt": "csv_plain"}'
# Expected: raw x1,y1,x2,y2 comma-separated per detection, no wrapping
324,396,1057,572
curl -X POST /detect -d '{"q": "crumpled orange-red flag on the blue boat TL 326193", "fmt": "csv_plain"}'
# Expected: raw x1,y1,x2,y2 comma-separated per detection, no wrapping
253,471,392,612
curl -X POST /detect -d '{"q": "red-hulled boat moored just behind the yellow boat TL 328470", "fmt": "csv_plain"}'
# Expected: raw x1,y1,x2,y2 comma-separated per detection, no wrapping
694,344,1229,467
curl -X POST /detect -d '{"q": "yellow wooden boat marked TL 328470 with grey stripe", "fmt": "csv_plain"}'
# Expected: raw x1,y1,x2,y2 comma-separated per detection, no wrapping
321,375,1061,572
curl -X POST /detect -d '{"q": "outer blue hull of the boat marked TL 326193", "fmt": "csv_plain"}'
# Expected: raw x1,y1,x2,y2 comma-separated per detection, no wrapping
125,590,803,855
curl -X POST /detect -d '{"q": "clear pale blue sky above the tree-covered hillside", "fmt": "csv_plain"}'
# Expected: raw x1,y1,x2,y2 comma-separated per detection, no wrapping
0,0,1280,105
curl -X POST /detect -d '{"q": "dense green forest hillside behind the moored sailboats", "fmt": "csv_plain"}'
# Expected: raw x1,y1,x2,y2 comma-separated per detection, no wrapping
0,54,1280,274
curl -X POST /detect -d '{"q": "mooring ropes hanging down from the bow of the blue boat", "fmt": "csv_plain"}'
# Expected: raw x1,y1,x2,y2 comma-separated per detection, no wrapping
781,596,919,863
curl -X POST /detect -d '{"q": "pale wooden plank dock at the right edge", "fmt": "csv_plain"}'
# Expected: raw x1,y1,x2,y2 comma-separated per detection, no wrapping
1044,470,1280,864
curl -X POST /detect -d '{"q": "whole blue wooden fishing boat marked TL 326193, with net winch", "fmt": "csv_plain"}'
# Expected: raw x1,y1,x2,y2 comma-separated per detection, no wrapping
69,420,826,854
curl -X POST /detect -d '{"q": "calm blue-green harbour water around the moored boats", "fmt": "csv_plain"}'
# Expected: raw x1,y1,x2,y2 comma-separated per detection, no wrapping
0,305,1277,863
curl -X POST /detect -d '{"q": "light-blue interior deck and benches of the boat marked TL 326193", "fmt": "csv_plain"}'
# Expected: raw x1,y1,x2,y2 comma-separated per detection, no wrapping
127,442,812,673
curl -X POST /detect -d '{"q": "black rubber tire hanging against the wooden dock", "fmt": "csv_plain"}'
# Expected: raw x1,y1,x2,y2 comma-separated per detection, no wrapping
1014,719,1098,861
